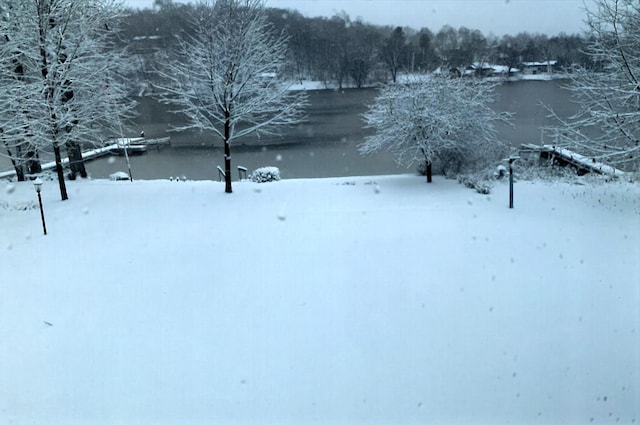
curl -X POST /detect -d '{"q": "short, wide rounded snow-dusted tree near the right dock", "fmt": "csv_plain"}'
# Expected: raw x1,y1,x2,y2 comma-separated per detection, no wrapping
359,76,510,182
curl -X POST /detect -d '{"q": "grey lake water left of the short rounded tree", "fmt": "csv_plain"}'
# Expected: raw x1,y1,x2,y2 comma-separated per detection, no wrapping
88,89,408,180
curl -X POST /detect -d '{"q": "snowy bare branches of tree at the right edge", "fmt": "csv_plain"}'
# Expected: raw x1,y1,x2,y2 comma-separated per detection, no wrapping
548,0,640,171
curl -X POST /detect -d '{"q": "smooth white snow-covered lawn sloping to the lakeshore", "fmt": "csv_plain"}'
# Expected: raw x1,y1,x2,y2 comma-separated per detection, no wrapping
0,175,640,425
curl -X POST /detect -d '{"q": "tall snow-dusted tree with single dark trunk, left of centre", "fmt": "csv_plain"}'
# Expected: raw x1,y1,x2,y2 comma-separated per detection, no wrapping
158,0,306,193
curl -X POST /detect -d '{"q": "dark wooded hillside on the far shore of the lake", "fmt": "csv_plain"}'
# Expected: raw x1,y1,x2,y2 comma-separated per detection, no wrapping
122,0,593,88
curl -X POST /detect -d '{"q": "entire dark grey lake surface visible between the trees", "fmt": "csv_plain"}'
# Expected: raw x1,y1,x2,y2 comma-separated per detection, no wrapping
1,80,576,180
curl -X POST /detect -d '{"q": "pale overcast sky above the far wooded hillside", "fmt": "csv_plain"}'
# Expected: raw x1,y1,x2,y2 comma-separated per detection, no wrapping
125,0,592,35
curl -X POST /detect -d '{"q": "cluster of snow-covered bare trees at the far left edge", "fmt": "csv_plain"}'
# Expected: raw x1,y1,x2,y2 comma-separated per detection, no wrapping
0,0,134,200
